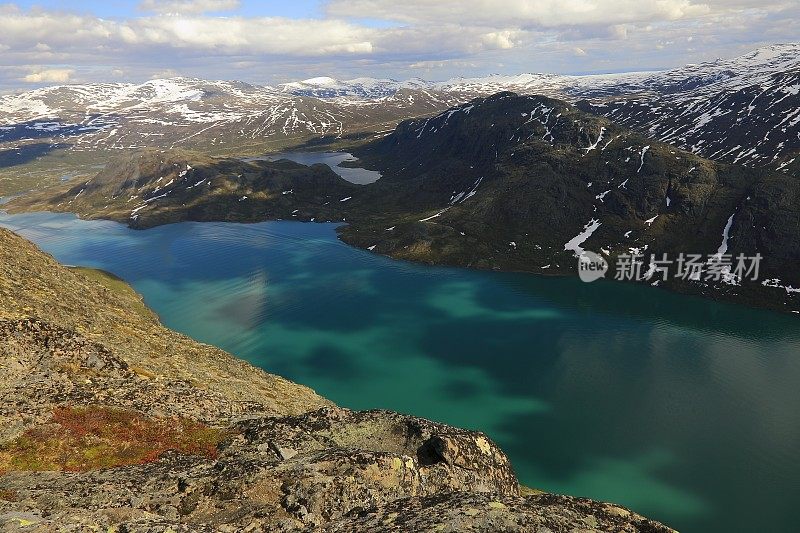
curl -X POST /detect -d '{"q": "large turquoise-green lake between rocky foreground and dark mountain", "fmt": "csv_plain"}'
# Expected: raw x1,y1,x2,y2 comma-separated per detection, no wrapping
0,209,800,533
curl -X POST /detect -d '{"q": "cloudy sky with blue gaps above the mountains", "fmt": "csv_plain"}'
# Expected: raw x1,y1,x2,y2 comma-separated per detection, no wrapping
0,0,800,92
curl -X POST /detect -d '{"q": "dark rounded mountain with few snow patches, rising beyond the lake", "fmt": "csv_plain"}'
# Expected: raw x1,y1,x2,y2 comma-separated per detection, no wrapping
342,93,800,310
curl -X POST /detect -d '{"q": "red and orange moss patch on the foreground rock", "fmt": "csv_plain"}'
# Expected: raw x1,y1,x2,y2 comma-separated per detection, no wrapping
0,407,227,474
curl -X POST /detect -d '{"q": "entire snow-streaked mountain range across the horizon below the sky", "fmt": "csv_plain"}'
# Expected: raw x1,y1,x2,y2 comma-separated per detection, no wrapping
0,43,800,194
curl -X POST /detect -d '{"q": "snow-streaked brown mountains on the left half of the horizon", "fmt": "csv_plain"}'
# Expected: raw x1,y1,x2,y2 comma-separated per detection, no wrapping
0,78,462,155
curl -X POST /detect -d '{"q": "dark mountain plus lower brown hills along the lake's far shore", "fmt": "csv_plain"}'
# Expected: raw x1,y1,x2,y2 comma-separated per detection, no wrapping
8,93,800,312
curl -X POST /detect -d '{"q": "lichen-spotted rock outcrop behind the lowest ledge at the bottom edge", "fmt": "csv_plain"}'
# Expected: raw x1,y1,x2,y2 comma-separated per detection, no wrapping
0,408,519,529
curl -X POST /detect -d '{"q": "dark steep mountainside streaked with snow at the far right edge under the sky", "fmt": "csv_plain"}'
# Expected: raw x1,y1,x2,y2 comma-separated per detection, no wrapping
580,44,800,174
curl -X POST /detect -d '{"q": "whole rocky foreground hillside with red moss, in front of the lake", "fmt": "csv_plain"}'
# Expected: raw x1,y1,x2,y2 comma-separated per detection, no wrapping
0,230,671,532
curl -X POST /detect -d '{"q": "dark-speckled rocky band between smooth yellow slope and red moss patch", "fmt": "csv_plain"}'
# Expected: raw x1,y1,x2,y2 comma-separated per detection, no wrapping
0,318,267,442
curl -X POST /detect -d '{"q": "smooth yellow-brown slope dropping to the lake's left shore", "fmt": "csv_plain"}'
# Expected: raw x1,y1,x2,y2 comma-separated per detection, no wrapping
0,224,330,414
